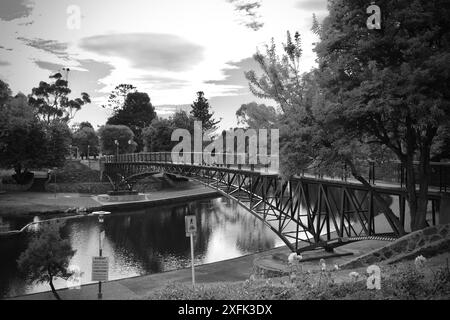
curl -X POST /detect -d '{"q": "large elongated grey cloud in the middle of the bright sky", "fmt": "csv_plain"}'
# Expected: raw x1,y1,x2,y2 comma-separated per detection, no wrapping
80,33,203,71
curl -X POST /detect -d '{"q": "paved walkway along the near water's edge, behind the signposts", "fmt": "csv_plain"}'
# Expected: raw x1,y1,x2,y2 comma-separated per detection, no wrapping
12,241,386,300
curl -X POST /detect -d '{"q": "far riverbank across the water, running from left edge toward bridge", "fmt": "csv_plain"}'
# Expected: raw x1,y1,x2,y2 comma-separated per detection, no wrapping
0,184,219,217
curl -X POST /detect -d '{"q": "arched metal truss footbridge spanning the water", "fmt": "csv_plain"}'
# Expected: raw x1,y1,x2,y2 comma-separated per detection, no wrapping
101,153,450,252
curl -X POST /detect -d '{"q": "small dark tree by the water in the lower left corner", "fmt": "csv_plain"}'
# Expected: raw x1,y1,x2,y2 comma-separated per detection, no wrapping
17,222,76,300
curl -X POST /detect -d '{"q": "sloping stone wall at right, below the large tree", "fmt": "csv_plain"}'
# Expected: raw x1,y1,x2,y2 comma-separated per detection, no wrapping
341,224,450,269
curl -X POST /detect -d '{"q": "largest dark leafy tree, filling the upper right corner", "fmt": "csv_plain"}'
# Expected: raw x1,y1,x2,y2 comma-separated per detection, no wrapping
316,0,450,230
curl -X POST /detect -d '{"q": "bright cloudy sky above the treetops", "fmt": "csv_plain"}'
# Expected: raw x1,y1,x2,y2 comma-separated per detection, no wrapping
0,0,327,129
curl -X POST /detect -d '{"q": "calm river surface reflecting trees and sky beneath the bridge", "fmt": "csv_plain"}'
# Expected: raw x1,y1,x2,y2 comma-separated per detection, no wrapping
0,198,283,297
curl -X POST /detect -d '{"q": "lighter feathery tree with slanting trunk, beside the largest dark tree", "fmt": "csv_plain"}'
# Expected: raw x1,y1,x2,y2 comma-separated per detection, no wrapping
246,32,404,233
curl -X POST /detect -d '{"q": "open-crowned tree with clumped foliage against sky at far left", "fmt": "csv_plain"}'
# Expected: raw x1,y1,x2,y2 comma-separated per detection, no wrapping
29,73,91,123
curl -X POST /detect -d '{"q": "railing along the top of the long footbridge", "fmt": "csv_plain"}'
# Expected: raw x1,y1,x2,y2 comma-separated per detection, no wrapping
100,152,450,192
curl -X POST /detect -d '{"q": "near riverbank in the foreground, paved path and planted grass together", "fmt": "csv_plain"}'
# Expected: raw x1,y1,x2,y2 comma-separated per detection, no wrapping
10,240,450,300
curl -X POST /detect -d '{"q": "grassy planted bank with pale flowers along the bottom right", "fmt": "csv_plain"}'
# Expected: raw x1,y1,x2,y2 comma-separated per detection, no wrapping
144,253,450,300
